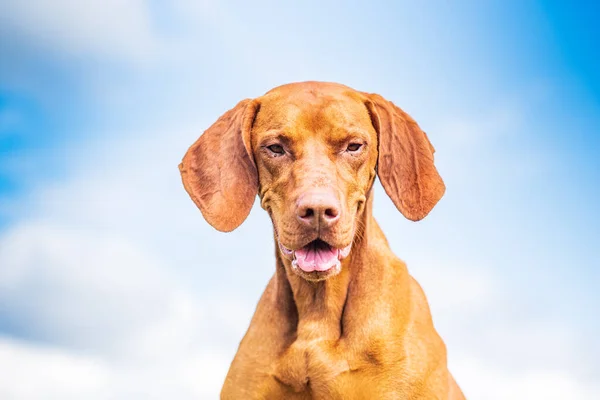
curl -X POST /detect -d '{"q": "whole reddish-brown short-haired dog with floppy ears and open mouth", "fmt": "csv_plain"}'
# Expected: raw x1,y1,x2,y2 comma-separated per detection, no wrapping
180,82,464,400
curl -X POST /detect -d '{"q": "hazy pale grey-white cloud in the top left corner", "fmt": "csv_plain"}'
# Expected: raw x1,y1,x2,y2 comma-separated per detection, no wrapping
0,0,159,60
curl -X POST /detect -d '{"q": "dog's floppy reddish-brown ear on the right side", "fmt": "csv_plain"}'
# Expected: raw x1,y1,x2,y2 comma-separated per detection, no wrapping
366,94,446,221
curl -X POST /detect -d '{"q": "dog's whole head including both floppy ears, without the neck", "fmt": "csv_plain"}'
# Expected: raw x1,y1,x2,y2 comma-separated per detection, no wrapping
179,82,445,280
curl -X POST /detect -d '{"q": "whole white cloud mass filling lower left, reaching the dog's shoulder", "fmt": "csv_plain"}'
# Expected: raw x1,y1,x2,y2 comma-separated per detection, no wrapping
0,216,246,399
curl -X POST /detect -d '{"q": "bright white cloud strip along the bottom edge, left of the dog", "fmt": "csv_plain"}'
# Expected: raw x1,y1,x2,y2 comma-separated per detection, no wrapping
0,337,229,400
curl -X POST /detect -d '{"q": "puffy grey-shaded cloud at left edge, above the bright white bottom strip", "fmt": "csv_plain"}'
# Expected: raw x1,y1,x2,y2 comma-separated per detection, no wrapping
0,223,196,352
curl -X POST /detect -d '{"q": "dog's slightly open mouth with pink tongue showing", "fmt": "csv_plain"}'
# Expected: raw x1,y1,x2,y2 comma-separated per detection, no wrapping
279,239,352,272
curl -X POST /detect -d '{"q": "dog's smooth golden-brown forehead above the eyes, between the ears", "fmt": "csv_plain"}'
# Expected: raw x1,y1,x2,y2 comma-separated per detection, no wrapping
255,82,371,134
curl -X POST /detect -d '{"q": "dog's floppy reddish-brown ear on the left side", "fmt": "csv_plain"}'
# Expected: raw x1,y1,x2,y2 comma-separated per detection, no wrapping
179,99,259,232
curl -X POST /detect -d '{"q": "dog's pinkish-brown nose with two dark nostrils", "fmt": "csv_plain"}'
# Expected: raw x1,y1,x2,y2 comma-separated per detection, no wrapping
296,191,340,228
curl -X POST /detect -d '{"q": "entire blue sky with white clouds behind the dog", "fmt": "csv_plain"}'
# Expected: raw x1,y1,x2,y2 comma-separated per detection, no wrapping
0,0,600,400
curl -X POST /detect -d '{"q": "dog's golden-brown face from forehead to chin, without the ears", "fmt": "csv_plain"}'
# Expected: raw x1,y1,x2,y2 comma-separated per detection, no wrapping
251,86,377,280
